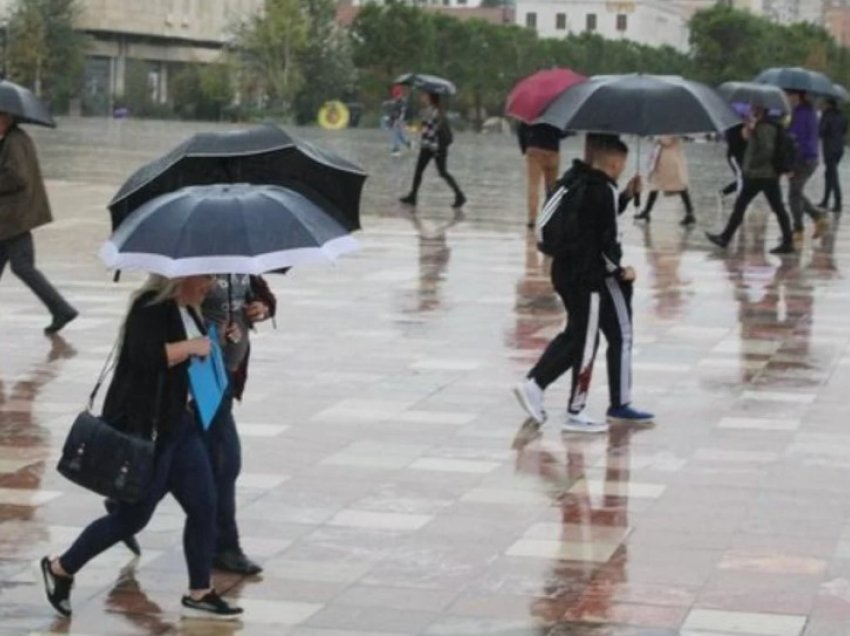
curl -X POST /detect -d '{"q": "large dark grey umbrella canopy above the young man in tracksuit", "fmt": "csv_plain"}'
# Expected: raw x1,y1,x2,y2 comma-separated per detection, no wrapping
535,74,740,137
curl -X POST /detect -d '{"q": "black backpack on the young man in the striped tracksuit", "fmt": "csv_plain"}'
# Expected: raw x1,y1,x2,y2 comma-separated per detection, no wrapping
536,172,587,258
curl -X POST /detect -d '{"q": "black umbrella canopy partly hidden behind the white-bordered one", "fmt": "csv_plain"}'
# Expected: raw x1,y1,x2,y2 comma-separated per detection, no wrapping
109,124,366,231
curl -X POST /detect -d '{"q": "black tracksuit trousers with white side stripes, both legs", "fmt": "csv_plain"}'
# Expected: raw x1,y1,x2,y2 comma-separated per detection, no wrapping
528,263,633,413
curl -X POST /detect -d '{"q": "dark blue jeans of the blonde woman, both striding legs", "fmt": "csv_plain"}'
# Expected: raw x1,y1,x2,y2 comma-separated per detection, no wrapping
59,412,216,590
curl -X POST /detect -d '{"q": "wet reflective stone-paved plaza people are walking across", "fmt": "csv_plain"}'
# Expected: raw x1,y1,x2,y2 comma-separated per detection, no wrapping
0,121,850,636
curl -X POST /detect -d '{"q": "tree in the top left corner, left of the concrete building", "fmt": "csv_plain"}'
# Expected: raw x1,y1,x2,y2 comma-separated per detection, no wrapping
4,0,86,109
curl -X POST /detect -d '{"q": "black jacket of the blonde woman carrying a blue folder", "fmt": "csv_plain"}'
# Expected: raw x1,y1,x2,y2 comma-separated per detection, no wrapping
103,292,205,439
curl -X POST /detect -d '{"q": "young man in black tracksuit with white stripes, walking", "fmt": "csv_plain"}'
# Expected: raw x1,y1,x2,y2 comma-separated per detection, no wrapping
515,138,653,433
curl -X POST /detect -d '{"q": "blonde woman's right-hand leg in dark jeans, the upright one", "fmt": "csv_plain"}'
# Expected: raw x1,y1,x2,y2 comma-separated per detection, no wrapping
168,417,216,591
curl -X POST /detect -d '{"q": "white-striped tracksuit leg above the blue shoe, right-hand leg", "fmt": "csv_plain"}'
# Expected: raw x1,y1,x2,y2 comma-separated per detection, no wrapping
599,277,633,408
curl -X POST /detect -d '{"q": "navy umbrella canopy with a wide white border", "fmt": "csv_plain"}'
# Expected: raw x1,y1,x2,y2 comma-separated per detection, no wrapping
100,183,358,278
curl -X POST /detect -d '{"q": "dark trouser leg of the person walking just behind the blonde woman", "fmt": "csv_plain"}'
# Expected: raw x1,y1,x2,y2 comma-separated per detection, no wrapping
207,395,242,554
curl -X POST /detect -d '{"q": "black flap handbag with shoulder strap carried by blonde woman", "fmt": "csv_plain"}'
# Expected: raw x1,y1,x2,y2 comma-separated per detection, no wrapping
56,343,157,504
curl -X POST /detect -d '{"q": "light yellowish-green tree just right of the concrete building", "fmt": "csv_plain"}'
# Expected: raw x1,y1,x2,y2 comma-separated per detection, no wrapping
233,0,308,113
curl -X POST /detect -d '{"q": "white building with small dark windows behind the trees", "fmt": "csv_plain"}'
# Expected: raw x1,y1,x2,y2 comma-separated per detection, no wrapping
516,0,688,51
